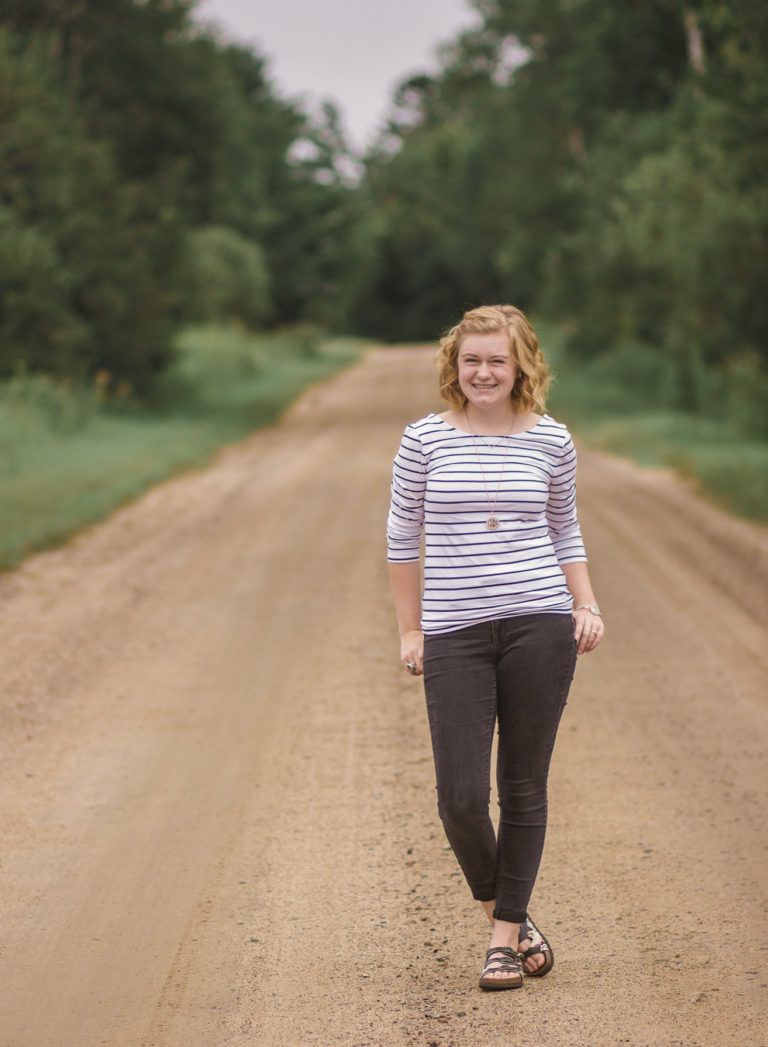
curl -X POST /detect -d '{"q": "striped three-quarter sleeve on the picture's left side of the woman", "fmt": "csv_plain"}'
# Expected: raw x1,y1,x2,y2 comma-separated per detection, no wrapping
387,425,427,563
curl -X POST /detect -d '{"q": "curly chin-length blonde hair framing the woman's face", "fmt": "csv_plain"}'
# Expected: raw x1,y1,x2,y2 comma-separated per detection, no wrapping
435,306,551,414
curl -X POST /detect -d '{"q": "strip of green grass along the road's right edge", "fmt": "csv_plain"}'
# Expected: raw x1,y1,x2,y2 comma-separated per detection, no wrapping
539,325,768,524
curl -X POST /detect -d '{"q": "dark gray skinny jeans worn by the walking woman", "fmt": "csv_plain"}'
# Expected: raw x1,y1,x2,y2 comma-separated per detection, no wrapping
424,614,577,923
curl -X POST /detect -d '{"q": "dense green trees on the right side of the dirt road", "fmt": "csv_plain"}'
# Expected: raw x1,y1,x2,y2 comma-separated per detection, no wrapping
355,0,768,432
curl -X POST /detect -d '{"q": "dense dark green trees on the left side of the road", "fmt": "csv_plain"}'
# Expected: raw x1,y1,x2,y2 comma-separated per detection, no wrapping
0,0,355,393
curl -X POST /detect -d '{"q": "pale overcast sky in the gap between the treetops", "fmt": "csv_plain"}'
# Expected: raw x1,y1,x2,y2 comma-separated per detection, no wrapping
197,0,477,148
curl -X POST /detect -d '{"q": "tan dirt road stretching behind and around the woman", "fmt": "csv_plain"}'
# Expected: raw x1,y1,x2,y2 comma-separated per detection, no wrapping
0,351,768,1047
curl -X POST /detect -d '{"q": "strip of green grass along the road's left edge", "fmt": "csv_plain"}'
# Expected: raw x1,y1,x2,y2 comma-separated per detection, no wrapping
0,328,363,569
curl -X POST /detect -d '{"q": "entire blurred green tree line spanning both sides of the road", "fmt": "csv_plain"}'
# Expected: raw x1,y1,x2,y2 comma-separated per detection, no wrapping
0,0,768,431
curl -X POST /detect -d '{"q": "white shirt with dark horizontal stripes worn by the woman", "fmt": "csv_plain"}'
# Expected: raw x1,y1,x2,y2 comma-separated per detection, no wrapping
387,414,587,633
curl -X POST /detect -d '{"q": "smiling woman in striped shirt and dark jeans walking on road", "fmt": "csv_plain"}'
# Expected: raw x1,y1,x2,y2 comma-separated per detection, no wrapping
387,306,603,989
